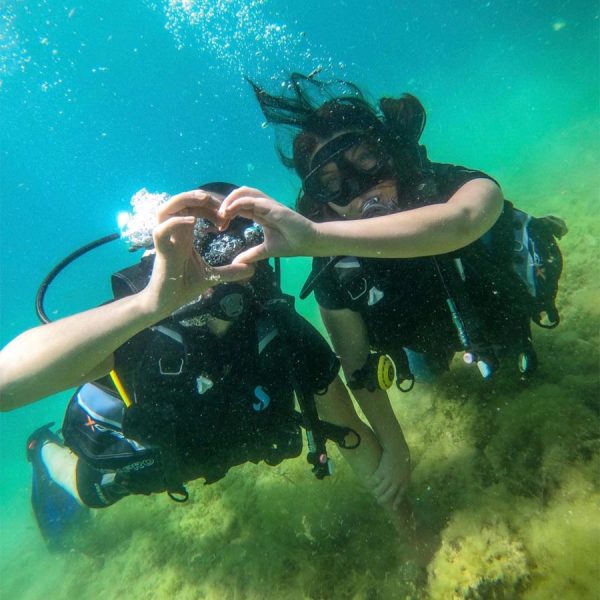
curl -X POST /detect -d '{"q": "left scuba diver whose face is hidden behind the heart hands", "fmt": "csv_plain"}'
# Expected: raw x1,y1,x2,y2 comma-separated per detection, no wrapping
0,183,409,547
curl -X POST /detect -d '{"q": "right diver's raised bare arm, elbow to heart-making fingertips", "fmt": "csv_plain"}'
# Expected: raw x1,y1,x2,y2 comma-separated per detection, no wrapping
220,178,503,263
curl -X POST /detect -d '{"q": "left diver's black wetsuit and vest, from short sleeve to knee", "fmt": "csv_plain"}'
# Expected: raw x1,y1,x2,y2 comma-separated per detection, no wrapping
63,307,339,507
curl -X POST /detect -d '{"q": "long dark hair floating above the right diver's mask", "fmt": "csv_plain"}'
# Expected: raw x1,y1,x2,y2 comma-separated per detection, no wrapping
250,73,426,220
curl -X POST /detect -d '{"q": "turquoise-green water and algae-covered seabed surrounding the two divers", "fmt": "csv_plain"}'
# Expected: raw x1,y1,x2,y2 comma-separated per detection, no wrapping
0,0,600,599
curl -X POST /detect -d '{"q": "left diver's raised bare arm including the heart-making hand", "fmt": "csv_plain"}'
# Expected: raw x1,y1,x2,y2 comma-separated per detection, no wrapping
0,191,253,411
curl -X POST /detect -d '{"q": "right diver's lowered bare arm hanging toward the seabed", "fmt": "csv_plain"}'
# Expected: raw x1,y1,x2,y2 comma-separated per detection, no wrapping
321,308,410,506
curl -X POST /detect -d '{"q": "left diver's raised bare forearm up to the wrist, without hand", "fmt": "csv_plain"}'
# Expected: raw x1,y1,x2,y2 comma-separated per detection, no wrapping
0,294,160,411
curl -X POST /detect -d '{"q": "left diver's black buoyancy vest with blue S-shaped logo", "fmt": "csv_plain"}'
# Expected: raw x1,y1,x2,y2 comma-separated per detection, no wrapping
63,304,302,493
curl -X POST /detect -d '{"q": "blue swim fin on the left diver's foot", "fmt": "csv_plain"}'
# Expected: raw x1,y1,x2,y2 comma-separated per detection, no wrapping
27,423,88,550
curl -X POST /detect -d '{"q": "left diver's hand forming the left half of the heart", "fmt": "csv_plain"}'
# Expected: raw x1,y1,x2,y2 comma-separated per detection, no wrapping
142,190,254,318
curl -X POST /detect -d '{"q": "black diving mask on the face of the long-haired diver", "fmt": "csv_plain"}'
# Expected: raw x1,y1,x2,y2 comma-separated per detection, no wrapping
303,131,393,206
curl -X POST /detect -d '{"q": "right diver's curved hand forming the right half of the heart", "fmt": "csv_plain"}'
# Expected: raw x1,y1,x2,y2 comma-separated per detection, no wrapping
219,187,316,264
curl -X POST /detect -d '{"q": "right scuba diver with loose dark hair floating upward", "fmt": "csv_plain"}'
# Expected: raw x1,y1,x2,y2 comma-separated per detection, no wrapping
220,74,566,502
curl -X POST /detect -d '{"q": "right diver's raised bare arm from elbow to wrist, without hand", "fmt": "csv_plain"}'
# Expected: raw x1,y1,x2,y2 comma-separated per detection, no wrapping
311,179,504,258
